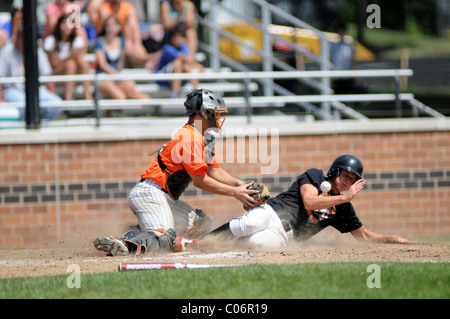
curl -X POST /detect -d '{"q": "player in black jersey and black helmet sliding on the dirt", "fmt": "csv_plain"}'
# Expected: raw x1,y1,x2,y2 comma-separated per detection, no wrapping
206,154,411,249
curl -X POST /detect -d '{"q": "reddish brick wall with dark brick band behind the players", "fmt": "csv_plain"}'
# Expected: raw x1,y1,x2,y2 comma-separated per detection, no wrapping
0,125,450,247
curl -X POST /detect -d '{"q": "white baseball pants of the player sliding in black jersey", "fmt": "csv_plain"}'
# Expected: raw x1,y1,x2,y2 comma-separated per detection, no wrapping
229,204,292,249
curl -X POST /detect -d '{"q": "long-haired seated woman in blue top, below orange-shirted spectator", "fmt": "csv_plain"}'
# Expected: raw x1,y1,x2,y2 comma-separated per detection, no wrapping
95,15,150,99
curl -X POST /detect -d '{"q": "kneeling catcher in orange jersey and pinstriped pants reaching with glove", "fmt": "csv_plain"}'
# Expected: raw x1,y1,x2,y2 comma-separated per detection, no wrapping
94,89,258,256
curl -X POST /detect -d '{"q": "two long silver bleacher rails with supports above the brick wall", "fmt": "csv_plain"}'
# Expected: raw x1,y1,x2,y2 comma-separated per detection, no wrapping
0,69,445,126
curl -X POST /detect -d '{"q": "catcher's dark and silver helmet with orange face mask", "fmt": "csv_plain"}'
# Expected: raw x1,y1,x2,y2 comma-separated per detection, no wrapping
184,89,228,130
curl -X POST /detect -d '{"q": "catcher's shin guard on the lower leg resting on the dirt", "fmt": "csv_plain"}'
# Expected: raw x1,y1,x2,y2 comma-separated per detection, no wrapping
122,229,177,255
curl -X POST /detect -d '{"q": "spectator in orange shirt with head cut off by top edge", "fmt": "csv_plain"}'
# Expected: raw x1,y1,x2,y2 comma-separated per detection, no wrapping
88,0,154,66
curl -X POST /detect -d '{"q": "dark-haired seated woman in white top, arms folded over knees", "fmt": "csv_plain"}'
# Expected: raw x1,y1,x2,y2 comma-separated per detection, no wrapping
43,15,93,100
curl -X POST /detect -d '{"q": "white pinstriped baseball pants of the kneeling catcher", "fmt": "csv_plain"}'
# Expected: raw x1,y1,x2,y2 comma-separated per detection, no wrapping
128,179,195,234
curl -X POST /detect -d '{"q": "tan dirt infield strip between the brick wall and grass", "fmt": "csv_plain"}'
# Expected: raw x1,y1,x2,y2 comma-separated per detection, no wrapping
0,233,450,278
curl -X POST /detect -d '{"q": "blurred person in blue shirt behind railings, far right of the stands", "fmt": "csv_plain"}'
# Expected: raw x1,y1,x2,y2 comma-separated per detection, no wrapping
330,22,356,94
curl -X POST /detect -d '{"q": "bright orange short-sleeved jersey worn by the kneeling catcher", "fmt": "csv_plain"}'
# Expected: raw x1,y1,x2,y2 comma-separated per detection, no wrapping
141,124,220,191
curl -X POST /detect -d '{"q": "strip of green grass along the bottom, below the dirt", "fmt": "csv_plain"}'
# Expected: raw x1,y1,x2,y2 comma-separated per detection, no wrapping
0,263,450,299
